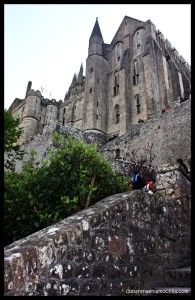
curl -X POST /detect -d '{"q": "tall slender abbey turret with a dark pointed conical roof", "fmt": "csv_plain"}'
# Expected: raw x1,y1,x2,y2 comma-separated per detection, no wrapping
83,19,108,132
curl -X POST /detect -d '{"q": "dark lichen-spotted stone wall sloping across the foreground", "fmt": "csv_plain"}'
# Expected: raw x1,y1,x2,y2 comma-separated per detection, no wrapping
5,191,190,296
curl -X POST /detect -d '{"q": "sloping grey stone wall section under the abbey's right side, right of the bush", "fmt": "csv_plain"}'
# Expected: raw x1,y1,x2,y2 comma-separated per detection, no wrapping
102,100,191,166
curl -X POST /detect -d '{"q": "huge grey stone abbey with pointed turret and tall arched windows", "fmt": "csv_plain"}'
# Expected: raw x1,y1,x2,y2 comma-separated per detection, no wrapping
9,16,191,143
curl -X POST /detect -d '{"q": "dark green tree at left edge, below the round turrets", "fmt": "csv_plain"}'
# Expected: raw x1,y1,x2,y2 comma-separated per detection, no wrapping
4,110,24,169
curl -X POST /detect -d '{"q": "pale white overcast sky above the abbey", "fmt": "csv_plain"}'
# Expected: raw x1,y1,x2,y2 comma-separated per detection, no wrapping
4,4,191,108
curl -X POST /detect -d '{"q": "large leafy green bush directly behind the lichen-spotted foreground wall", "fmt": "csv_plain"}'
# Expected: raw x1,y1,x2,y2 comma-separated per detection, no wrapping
5,133,128,244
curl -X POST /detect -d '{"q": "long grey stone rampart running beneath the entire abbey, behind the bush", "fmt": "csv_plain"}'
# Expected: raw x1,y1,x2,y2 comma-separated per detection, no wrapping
13,100,191,171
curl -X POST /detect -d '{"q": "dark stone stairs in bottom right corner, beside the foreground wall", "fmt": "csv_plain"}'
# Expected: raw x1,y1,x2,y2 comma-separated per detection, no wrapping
155,265,191,296
